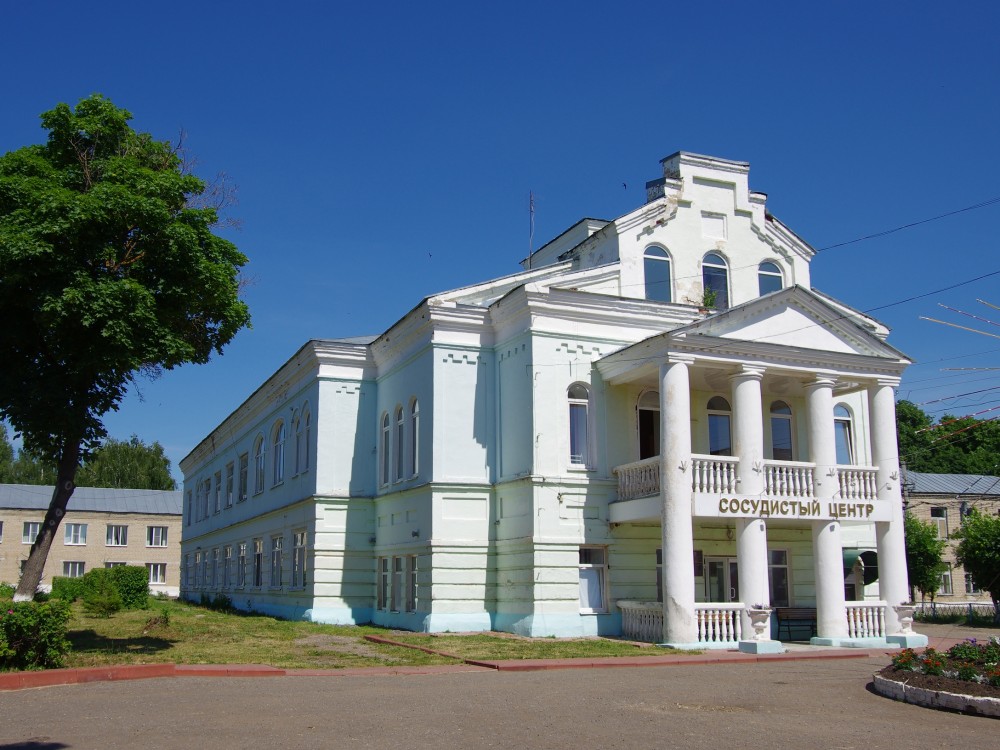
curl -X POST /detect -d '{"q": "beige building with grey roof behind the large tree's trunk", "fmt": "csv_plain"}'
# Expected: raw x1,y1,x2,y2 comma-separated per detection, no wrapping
0,484,181,596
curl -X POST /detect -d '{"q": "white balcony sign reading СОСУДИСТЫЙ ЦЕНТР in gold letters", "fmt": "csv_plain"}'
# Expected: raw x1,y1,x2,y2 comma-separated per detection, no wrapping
694,493,890,521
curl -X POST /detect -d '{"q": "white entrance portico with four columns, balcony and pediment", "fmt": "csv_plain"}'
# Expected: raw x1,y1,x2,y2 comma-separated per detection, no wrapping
598,289,928,647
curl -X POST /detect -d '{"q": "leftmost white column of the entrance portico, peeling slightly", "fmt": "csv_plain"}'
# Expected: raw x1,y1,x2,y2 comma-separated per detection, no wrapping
660,359,698,644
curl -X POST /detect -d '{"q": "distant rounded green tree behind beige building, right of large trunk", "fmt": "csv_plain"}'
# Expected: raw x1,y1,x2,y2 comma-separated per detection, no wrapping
76,435,177,490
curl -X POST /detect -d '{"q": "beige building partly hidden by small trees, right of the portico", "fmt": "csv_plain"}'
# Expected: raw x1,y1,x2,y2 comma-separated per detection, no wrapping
903,471,1000,603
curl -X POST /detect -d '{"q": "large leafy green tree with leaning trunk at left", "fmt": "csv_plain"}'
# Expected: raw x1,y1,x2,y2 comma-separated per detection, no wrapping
0,95,249,599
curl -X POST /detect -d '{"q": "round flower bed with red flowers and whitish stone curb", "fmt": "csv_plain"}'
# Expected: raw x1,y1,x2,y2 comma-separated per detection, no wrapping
880,636,1000,699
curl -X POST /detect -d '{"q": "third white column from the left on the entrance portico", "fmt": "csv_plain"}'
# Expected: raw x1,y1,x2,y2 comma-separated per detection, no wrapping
806,376,847,638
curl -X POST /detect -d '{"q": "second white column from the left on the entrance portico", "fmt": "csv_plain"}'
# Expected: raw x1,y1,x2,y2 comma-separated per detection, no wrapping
730,367,771,633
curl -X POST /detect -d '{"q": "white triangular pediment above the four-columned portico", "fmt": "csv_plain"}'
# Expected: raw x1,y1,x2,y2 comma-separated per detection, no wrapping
674,287,903,359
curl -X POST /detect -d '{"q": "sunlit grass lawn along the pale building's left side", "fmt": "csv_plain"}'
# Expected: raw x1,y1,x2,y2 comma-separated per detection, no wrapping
66,599,684,669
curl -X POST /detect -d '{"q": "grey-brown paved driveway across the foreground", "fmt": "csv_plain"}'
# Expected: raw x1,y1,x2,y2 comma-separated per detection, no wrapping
0,626,1000,750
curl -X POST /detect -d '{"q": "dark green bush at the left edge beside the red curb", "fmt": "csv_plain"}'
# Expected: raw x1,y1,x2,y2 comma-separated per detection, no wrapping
0,599,70,670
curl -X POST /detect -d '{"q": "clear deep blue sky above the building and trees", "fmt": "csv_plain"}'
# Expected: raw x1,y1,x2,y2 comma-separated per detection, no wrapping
0,0,1000,476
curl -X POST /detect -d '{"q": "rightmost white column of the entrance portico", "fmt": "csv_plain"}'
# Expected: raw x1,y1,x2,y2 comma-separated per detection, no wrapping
868,380,909,635
